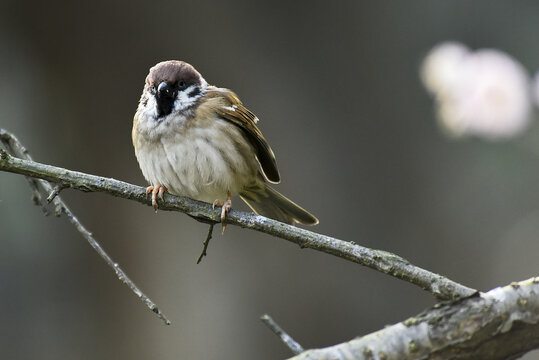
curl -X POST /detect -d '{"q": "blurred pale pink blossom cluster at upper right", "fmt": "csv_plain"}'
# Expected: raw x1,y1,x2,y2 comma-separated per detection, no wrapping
421,42,531,140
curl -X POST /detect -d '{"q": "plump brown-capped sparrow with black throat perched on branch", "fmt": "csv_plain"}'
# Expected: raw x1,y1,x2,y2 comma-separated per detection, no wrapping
132,60,318,231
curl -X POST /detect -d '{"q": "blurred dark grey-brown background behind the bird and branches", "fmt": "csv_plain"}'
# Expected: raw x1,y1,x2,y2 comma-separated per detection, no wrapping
0,0,539,360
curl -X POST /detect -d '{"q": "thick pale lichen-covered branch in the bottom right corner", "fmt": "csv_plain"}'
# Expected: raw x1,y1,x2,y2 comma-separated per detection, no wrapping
292,278,539,360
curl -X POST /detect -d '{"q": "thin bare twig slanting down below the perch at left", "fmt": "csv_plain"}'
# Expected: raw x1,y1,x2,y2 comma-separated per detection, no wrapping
0,129,170,325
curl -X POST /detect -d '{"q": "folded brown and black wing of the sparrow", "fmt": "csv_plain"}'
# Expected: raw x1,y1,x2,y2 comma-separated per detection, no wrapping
208,89,281,183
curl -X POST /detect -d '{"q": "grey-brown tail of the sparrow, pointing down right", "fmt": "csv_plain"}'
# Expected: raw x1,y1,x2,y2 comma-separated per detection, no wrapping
240,185,318,225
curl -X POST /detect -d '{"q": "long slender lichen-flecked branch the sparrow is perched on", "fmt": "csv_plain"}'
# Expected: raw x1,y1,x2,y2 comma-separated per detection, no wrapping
0,129,477,300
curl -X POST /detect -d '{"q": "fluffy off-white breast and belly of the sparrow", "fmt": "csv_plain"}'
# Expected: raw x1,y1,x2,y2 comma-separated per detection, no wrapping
134,111,260,203
